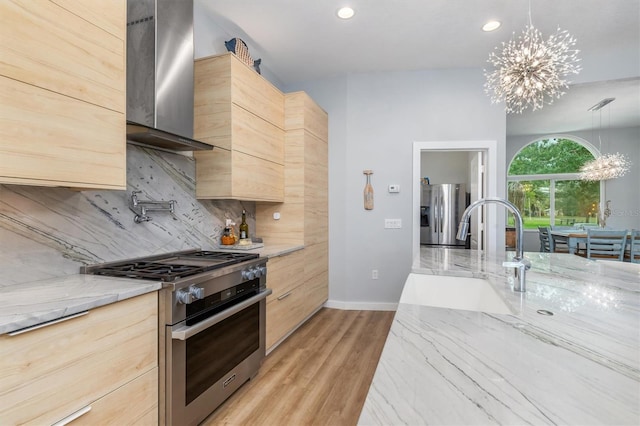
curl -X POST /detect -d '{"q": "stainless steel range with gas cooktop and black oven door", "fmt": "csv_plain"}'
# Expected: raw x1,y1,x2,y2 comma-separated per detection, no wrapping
84,250,271,426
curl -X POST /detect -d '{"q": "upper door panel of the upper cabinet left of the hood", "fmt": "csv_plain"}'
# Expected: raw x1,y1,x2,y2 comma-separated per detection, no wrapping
0,0,126,112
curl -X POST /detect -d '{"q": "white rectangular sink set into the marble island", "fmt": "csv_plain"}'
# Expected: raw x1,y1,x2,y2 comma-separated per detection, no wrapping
400,273,514,314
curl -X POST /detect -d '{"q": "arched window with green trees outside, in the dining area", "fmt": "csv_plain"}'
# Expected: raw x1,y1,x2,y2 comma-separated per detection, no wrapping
507,139,600,229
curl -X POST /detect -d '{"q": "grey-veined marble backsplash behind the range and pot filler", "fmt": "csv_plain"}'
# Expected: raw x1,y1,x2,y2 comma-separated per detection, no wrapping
0,145,255,286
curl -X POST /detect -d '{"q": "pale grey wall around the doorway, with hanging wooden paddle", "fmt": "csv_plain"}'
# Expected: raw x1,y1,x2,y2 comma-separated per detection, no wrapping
287,69,506,308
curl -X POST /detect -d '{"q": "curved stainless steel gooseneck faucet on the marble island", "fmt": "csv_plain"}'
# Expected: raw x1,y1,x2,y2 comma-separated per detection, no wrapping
456,197,531,292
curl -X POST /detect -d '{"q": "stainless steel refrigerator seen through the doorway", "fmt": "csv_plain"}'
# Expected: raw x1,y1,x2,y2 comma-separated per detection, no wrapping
420,183,468,247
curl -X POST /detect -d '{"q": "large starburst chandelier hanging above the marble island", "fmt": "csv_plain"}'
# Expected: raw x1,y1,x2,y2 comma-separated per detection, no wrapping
484,3,581,114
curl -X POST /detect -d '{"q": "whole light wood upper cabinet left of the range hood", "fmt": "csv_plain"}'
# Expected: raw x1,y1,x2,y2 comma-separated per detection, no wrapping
0,0,126,189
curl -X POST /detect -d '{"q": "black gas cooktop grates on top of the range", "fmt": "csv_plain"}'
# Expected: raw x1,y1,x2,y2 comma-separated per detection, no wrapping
80,250,259,282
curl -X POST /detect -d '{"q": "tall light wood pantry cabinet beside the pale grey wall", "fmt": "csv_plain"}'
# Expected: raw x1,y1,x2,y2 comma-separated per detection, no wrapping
256,92,329,347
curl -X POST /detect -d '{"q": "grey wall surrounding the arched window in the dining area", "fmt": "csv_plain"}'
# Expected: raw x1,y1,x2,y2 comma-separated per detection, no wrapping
507,127,640,233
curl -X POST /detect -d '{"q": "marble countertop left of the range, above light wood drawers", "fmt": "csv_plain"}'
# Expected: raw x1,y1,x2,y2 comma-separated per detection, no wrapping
0,274,162,334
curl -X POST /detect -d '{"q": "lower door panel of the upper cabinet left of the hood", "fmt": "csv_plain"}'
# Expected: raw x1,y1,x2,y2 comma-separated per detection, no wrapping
0,76,126,189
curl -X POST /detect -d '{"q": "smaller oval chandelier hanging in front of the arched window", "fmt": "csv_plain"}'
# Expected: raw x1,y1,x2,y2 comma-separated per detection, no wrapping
580,98,631,182
